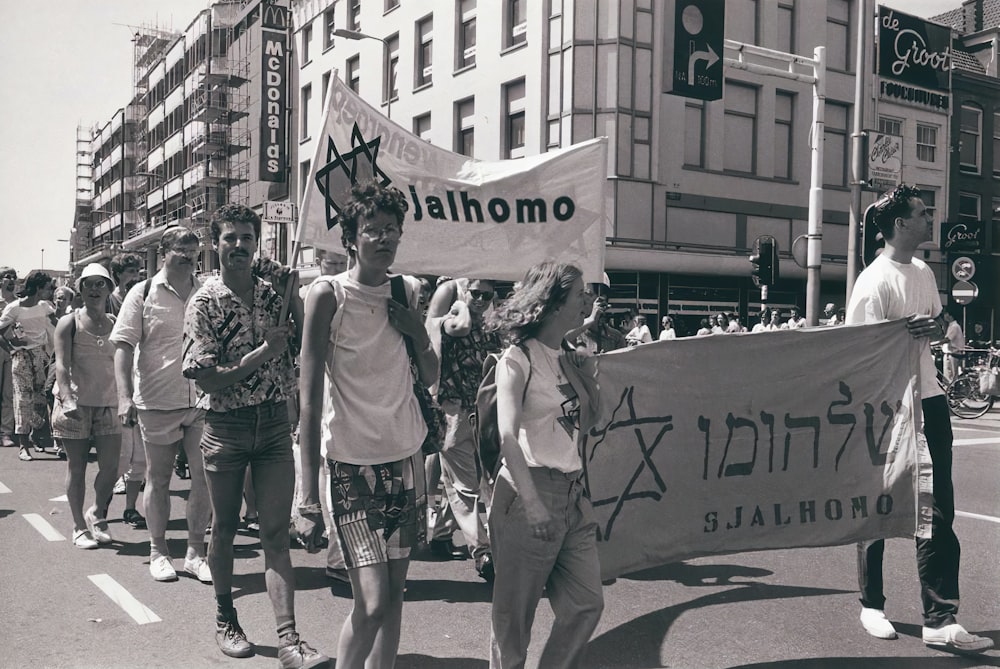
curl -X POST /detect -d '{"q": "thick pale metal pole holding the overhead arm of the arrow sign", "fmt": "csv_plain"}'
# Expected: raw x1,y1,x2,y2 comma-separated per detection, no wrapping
806,46,826,327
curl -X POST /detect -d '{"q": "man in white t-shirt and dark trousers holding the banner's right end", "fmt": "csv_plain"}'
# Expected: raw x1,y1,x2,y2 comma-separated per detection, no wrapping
847,184,993,653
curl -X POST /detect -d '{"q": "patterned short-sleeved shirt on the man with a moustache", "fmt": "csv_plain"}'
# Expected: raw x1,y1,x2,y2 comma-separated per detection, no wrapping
183,277,295,411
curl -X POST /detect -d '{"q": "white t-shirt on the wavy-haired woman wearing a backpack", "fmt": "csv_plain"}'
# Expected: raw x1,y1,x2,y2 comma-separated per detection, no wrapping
503,339,583,473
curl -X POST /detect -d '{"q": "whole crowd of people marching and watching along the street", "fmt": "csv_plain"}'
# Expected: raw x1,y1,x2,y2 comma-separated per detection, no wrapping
0,182,992,668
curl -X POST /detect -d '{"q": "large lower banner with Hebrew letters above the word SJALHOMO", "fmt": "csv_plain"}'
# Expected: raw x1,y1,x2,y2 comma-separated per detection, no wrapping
582,321,931,578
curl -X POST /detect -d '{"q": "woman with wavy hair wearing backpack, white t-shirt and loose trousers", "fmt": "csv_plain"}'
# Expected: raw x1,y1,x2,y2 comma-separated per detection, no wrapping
487,262,604,669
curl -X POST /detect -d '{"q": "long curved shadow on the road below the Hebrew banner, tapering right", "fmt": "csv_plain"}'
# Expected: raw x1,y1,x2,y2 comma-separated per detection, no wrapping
584,583,852,669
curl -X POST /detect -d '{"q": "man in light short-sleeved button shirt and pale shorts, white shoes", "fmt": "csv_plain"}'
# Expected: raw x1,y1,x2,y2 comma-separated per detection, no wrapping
111,226,212,583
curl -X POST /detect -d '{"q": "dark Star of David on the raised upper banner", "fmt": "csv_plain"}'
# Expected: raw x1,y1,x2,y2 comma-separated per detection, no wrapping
316,123,392,230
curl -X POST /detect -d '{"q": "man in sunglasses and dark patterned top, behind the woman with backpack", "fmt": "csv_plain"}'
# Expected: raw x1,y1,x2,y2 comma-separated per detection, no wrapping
427,279,500,582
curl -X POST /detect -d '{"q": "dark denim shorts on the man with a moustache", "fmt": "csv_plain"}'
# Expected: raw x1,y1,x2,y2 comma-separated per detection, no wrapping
201,401,295,472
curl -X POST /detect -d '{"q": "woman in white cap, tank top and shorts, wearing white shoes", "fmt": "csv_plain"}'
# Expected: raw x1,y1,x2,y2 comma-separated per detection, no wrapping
52,263,121,548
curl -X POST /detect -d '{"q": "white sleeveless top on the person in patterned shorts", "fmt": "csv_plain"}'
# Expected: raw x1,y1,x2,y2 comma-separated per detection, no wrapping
321,272,427,465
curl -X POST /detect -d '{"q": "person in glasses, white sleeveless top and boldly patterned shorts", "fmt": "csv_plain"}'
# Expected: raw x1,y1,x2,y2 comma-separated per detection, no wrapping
295,181,438,667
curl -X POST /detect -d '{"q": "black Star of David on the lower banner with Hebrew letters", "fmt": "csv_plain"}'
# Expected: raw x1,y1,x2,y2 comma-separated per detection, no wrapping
583,386,674,541
